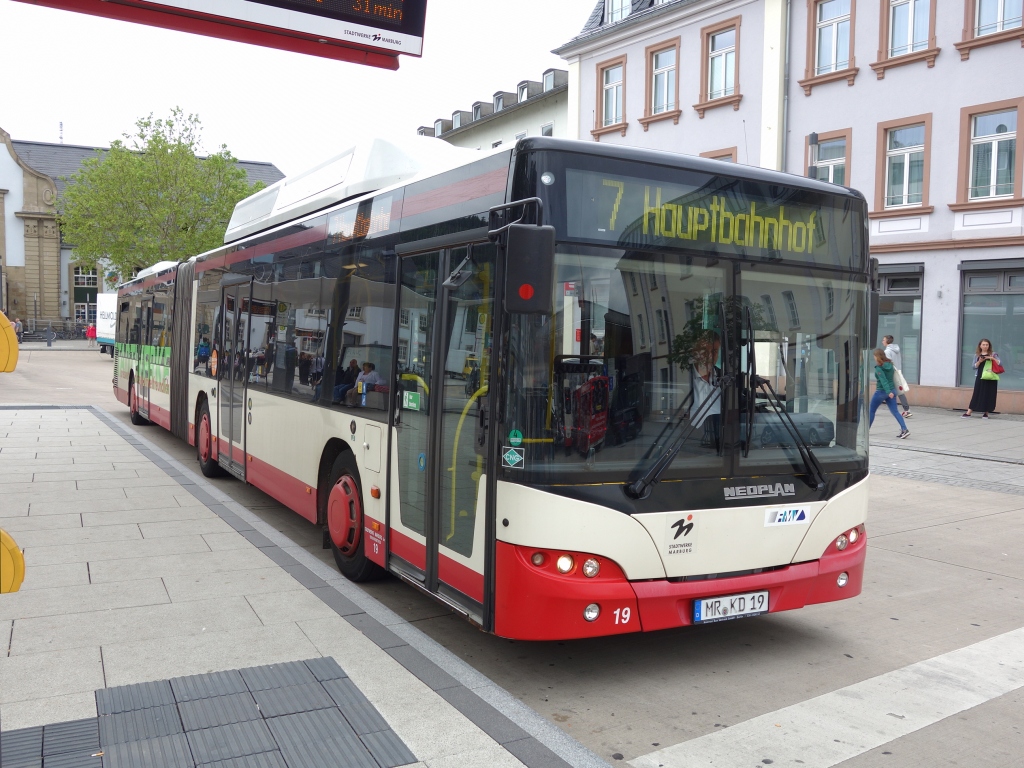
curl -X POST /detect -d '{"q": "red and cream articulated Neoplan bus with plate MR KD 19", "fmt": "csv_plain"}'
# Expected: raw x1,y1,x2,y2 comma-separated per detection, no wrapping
114,138,872,640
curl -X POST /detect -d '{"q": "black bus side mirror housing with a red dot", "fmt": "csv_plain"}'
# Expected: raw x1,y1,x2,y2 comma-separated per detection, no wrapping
505,224,555,314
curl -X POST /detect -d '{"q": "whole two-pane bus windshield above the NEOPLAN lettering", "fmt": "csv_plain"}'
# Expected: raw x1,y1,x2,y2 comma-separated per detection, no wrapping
502,247,863,483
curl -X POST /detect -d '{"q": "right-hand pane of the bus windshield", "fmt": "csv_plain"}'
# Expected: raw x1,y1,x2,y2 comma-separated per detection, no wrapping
737,270,870,471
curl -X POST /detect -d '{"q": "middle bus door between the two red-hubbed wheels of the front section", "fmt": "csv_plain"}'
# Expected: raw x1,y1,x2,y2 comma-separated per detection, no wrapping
217,281,250,480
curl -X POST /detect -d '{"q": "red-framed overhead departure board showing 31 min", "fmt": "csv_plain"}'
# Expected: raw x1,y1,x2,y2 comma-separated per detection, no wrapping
19,0,427,70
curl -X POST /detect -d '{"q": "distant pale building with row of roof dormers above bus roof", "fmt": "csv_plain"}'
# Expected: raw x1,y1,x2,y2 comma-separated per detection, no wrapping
418,70,570,150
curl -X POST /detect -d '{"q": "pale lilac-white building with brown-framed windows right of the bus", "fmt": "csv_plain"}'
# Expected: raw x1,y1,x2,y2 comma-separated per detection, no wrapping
556,0,1024,412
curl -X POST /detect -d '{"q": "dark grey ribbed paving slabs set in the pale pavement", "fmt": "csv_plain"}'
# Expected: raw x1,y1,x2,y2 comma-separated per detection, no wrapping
0,658,416,768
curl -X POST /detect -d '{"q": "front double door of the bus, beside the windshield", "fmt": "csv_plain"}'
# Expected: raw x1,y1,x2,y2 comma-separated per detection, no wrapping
391,243,496,624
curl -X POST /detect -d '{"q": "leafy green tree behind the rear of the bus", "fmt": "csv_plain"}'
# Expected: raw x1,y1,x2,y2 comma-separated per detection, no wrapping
58,108,263,284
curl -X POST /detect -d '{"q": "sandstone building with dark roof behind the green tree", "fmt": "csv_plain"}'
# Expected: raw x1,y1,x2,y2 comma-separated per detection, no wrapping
0,129,284,327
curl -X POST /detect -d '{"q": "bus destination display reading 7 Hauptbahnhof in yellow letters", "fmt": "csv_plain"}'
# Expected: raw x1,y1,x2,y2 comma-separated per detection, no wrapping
565,169,859,265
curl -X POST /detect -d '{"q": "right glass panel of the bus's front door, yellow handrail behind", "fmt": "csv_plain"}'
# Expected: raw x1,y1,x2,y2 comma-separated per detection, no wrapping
437,245,495,557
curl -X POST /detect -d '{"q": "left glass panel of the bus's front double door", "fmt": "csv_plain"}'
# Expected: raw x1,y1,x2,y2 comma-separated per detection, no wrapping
397,251,440,536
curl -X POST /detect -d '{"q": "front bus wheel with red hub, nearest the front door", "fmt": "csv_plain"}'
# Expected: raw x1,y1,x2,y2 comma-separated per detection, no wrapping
327,454,384,582
